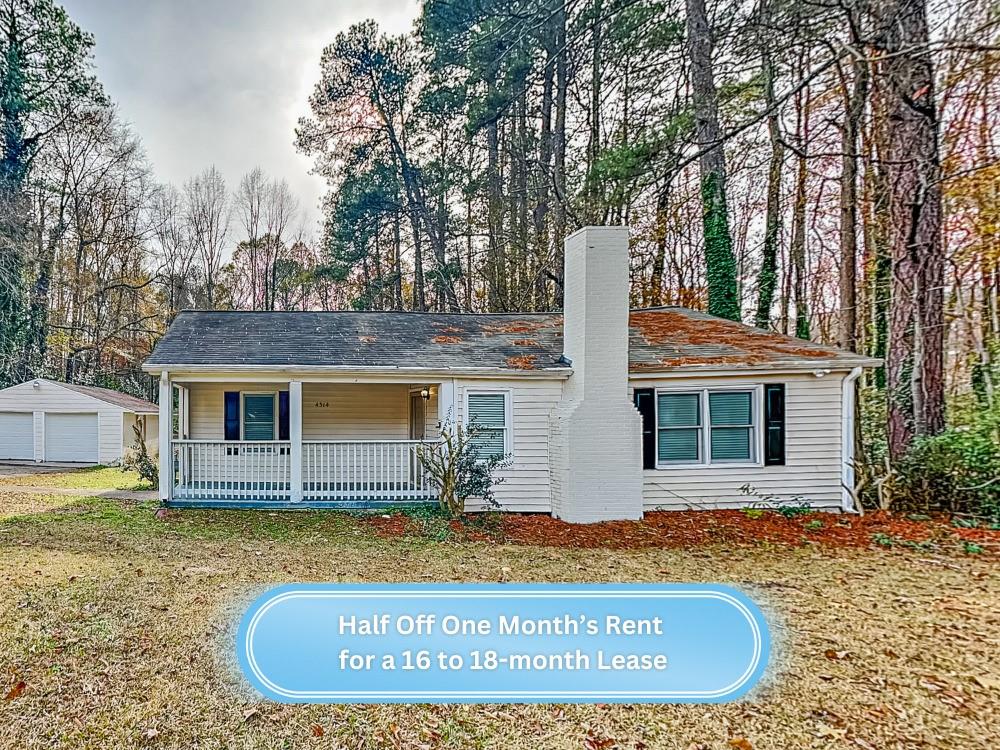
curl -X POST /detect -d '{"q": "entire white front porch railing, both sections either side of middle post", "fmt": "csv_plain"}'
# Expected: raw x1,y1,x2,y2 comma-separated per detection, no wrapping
171,440,437,502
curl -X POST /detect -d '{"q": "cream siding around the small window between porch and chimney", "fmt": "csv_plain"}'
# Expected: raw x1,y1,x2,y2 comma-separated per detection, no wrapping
455,378,562,513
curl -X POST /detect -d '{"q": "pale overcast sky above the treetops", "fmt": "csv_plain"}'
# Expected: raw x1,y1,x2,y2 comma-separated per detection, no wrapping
62,0,417,230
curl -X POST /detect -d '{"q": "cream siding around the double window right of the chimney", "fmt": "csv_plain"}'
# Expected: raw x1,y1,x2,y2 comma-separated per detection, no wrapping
631,373,844,510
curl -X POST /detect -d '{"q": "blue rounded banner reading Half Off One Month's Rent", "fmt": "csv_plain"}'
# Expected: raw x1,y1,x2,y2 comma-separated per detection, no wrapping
236,584,770,703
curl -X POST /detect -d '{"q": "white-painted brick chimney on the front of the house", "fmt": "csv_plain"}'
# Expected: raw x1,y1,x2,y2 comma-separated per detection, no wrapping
550,227,642,523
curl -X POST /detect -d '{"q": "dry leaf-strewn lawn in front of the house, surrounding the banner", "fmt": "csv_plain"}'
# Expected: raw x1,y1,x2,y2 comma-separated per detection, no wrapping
0,494,1000,750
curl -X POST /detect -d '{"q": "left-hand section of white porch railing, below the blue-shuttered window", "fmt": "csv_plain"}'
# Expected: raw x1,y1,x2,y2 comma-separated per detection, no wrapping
171,440,291,500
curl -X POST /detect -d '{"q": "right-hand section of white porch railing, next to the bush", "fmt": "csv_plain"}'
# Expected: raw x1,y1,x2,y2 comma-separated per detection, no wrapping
302,440,437,501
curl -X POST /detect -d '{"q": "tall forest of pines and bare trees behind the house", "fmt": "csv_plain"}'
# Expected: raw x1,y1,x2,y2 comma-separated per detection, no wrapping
0,0,1000,512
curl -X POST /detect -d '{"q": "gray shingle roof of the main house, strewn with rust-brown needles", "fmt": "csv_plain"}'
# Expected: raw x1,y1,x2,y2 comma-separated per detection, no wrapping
146,307,875,372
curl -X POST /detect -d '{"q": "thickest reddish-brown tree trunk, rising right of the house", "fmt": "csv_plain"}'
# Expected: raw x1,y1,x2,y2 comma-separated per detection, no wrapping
875,0,944,459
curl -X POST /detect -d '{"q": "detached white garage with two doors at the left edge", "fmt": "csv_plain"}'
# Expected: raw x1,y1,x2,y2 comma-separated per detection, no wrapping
0,378,159,464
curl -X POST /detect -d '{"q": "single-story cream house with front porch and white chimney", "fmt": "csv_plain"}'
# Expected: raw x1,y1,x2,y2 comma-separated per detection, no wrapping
144,227,878,522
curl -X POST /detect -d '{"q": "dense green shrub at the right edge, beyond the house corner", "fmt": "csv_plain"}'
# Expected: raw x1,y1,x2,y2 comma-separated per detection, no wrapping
893,405,1000,522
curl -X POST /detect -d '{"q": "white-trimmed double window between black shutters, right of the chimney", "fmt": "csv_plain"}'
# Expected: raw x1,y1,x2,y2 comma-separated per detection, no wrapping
656,388,760,466
